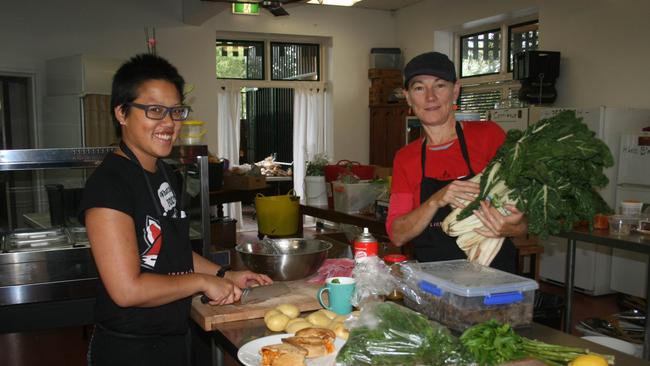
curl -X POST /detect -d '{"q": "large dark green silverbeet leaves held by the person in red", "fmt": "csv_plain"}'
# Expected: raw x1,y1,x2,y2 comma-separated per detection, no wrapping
457,111,614,237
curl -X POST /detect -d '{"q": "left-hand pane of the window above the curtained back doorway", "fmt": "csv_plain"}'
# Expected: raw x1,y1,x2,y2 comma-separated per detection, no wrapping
217,40,264,80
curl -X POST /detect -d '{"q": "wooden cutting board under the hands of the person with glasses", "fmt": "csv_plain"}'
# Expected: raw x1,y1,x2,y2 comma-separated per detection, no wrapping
191,280,321,331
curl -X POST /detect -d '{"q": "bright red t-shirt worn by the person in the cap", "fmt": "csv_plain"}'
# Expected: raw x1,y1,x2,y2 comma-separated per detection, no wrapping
386,121,506,237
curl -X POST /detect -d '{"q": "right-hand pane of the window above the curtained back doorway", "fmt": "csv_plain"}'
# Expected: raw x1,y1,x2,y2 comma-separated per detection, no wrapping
271,42,320,81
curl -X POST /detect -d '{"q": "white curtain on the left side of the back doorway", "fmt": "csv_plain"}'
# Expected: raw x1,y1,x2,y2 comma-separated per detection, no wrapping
217,87,243,229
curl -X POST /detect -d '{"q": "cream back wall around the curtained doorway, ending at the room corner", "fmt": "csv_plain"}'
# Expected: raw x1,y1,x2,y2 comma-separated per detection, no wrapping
0,0,396,162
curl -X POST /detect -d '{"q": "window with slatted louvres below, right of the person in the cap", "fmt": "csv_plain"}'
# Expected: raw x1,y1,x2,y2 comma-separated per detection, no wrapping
456,20,539,119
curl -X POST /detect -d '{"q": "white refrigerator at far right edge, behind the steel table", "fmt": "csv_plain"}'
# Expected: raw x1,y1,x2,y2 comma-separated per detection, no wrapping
611,132,650,298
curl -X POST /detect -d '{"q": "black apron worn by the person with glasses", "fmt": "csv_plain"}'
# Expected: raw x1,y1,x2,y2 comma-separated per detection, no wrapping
88,142,193,366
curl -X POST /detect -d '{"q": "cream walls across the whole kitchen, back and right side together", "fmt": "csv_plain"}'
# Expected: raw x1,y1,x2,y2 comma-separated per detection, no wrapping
0,0,650,162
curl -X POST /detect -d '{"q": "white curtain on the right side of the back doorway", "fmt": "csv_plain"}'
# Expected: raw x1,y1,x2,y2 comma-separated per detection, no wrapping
293,88,327,200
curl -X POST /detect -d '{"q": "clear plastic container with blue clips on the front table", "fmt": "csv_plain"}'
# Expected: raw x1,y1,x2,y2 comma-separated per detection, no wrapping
401,260,539,332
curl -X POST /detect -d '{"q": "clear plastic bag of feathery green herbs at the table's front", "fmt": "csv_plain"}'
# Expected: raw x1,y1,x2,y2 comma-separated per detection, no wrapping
336,302,471,366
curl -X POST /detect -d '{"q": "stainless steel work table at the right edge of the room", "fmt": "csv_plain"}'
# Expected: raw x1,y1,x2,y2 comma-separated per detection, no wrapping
558,229,650,360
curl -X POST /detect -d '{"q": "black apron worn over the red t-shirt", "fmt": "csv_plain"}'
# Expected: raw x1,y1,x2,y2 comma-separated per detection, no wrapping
411,122,517,273
